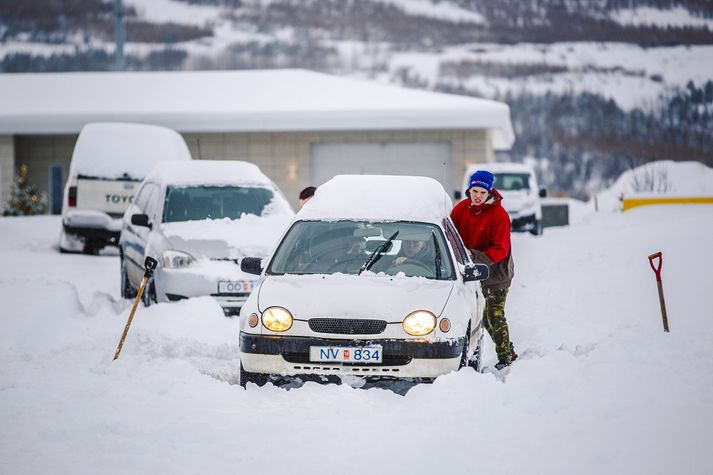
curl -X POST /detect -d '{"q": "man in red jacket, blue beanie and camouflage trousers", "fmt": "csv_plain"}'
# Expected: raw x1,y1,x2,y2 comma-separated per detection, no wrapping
451,170,517,370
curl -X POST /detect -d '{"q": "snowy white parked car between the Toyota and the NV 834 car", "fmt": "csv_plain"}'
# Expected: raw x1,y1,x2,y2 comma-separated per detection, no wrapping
119,160,294,316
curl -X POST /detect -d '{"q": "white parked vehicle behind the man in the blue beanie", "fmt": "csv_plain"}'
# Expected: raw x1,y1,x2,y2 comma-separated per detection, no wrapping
463,163,547,235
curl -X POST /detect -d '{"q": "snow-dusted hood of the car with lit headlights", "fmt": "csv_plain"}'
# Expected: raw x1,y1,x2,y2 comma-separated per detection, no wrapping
258,274,453,322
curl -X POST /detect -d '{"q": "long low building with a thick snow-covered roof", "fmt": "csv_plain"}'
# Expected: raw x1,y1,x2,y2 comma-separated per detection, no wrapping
0,70,514,212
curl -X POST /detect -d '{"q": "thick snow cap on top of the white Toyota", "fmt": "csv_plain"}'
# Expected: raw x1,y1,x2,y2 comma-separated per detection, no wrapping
70,122,191,180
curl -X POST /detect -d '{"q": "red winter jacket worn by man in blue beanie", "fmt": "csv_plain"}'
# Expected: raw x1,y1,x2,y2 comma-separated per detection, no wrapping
451,189,514,289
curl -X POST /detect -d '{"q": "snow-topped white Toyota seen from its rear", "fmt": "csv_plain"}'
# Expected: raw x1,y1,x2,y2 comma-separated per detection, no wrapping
59,123,191,254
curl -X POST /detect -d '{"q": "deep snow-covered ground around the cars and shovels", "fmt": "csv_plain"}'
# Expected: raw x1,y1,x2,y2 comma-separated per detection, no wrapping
0,205,713,474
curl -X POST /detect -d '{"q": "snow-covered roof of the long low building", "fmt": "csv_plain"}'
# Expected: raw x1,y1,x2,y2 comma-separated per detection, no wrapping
0,70,514,148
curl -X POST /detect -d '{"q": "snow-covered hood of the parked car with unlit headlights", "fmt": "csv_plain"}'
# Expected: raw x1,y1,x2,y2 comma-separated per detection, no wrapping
161,215,292,259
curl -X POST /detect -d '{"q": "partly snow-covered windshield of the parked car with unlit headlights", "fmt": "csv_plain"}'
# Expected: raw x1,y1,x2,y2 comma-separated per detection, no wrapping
163,186,273,223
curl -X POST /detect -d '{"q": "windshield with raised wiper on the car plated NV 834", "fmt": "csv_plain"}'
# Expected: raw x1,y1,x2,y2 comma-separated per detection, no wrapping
267,221,455,280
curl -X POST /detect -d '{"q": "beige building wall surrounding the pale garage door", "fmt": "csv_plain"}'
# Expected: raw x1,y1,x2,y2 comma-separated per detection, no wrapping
183,130,493,206
